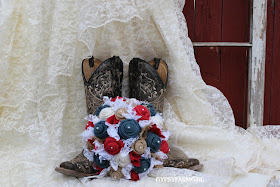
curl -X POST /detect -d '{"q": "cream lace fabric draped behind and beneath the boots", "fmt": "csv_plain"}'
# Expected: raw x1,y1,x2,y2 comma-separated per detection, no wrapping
0,0,280,186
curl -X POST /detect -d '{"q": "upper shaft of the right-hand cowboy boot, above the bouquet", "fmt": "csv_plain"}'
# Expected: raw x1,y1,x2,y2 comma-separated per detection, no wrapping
129,58,168,113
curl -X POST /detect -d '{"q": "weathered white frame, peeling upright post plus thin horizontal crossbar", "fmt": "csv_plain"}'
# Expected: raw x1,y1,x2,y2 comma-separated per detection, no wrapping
193,0,267,128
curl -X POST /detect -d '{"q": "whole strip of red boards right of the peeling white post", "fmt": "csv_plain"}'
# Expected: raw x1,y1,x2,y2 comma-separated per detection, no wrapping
264,0,280,125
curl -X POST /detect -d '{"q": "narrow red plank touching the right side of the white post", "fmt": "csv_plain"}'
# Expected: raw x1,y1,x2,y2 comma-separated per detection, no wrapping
263,0,275,125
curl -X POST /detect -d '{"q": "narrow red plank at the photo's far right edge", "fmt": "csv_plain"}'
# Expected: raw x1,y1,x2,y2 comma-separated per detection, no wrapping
270,0,280,125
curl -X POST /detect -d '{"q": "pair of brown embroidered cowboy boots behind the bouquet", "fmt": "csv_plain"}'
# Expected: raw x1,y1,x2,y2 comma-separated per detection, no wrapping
55,56,201,177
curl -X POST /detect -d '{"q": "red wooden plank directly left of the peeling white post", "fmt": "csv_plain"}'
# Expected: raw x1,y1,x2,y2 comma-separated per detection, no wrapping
221,0,250,128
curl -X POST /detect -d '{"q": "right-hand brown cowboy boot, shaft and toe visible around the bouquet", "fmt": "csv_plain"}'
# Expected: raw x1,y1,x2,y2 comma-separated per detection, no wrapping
129,58,202,170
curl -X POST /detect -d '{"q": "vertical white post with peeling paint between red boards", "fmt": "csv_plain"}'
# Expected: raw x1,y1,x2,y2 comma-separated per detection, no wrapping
247,0,267,127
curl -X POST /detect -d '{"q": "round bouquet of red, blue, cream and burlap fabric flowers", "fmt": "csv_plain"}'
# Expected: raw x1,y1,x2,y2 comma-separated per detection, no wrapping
82,97,170,181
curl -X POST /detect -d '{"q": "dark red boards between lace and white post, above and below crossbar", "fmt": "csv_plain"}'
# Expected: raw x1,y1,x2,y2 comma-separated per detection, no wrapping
184,0,249,128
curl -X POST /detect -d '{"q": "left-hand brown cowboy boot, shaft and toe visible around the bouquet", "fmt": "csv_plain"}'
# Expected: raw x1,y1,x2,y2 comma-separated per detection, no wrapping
55,56,123,177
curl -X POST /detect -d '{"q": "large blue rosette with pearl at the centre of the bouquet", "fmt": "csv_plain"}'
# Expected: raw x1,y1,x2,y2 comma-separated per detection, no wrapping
118,119,141,140
